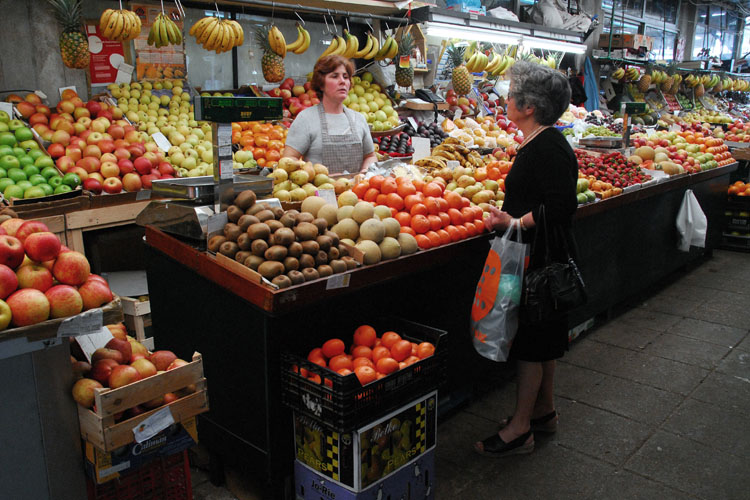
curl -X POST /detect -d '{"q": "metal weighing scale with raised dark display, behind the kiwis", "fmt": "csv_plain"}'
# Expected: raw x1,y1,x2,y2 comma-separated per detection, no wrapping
136,96,283,244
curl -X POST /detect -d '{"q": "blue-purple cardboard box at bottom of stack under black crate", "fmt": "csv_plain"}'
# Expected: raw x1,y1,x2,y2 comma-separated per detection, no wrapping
294,449,435,500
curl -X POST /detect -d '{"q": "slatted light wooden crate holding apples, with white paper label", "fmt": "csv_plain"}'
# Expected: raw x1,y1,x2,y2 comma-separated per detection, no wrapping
78,352,208,452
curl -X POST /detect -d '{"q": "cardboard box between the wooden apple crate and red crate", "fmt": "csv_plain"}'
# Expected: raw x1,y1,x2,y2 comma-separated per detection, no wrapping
83,417,198,484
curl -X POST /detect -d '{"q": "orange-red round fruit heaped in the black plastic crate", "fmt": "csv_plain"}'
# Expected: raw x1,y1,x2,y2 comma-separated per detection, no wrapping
294,325,435,385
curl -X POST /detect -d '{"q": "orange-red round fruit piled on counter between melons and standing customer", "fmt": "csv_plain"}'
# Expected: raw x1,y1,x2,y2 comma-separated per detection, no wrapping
352,175,484,249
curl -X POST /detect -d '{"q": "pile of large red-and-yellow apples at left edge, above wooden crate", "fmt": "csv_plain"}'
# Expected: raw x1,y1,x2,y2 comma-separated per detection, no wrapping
0,218,112,330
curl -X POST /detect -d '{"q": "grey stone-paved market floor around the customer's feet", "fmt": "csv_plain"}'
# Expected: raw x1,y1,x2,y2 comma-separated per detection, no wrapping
193,251,750,500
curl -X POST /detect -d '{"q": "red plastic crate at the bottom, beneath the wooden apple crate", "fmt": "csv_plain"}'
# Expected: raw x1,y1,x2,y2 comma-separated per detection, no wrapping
86,450,193,500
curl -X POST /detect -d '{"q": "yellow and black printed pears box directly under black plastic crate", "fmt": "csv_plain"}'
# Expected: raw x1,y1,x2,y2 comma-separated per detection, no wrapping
294,391,437,490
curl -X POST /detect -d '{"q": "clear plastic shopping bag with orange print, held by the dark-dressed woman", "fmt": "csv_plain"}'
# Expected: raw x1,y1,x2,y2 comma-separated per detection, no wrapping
471,224,526,361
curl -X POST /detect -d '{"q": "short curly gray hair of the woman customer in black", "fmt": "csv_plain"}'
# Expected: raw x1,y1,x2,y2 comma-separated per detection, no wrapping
510,61,570,125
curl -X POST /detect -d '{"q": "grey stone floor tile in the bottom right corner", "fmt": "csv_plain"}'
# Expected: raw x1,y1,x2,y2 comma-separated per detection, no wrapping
625,431,750,500
